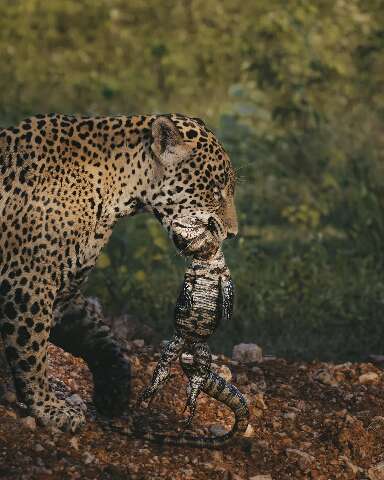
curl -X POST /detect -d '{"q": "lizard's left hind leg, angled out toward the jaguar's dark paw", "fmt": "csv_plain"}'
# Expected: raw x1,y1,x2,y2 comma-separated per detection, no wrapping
137,335,185,405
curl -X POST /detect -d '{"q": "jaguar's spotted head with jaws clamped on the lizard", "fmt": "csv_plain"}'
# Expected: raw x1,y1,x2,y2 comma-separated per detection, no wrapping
149,114,238,256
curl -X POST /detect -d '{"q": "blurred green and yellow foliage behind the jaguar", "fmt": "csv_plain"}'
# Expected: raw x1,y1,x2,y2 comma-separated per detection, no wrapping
0,0,384,359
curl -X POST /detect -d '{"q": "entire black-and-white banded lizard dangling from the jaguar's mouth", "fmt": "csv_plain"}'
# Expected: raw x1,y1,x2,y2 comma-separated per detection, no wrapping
139,250,249,447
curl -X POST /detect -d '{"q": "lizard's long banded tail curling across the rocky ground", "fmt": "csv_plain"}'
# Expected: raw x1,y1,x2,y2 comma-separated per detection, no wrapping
143,361,249,448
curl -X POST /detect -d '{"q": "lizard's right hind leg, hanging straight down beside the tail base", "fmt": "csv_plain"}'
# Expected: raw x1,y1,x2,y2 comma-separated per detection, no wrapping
184,342,212,428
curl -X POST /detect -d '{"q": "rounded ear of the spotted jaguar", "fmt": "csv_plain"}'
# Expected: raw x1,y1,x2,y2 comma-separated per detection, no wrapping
151,117,192,166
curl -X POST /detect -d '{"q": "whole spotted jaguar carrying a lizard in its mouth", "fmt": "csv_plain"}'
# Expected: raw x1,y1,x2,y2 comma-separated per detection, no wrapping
0,114,237,431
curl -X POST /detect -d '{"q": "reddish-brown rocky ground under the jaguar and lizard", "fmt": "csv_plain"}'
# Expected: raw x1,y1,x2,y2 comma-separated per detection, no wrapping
0,341,384,480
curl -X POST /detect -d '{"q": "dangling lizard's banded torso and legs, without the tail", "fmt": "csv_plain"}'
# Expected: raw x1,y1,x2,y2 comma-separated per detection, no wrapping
139,250,233,426
